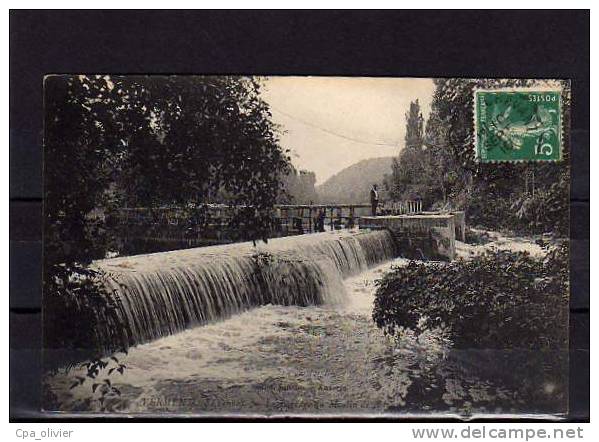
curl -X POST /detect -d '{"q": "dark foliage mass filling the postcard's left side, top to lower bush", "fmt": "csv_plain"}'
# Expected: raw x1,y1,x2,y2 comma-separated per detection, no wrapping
44,75,289,364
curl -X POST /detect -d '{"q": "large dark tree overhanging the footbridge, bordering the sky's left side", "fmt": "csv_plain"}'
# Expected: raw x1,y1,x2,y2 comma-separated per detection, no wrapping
113,76,289,209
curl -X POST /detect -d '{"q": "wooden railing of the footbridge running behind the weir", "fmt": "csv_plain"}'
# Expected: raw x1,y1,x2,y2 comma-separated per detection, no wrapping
102,202,421,254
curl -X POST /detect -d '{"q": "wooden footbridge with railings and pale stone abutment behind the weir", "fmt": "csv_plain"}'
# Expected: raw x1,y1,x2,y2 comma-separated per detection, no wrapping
105,201,465,259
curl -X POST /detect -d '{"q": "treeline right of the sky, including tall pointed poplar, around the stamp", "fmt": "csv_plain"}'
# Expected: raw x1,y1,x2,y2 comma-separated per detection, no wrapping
386,79,570,236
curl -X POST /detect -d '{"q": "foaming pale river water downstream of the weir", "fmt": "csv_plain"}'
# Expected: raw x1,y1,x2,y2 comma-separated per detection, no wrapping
49,231,567,416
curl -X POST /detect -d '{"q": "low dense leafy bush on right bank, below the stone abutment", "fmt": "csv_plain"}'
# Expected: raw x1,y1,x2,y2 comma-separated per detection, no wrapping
373,244,568,349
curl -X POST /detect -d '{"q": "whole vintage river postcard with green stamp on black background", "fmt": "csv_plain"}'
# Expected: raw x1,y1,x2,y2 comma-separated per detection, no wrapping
43,74,570,418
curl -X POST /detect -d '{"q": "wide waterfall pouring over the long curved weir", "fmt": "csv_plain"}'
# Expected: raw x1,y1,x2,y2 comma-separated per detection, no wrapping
89,230,396,351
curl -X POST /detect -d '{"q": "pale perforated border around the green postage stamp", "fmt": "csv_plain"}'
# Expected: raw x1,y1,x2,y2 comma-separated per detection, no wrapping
472,85,565,164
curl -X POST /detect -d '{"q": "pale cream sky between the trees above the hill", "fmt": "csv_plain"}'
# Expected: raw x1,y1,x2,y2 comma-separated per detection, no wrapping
262,77,434,184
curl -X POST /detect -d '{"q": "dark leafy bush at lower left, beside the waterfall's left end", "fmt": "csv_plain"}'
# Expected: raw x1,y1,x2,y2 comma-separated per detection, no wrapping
42,265,128,410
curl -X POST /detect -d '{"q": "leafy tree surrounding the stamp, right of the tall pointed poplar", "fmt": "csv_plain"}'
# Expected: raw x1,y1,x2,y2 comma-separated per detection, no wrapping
426,79,570,235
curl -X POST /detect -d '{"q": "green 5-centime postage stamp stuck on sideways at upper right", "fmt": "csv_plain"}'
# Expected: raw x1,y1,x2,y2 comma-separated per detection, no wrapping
474,89,562,162
